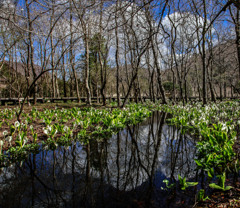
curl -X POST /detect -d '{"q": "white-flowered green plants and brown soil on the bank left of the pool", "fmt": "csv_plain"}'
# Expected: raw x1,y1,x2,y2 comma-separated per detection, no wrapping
0,104,151,166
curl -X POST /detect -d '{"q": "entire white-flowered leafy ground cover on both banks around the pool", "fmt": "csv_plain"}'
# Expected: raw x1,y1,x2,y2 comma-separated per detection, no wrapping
0,101,240,207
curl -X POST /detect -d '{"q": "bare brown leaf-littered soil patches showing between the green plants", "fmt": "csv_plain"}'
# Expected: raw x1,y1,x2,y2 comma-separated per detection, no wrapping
0,103,240,208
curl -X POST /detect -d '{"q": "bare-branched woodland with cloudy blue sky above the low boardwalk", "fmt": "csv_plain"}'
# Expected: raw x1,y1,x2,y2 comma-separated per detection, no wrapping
0,0,240,106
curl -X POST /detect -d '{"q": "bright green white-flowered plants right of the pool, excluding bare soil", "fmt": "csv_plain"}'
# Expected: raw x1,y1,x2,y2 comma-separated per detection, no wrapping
158,101,240,200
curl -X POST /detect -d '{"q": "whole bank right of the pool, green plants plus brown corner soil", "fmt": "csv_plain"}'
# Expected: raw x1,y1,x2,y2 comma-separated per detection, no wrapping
159,101,240,207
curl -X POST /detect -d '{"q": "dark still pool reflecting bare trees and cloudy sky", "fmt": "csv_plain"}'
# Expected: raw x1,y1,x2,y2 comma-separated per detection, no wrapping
0,113,196,208
